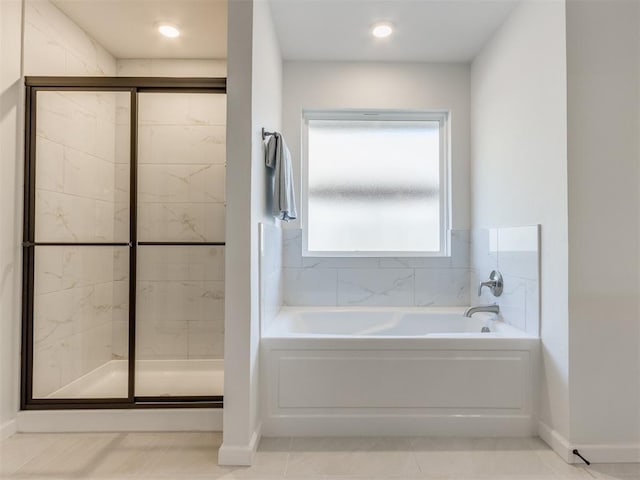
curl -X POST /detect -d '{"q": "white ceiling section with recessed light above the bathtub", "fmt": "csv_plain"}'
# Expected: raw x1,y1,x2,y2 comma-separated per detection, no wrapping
268,0,518,62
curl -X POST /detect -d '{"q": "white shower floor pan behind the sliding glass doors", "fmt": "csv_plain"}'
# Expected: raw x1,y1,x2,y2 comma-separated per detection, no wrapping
44,360,224,398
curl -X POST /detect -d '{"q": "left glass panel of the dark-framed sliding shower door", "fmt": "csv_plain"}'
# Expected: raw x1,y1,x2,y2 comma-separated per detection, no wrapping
30,89,131,399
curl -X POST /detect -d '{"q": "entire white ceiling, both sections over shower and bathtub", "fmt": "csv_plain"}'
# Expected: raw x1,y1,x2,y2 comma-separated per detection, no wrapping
52,0,519,62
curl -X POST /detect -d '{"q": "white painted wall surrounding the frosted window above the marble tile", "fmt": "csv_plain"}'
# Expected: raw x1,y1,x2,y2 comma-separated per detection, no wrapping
282,62,469,230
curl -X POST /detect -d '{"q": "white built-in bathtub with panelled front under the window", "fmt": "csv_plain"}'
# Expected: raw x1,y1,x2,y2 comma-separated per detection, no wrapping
261,307,539,436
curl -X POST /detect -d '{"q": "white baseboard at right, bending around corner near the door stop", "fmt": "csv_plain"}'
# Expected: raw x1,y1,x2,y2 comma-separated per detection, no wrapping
538,422,640,463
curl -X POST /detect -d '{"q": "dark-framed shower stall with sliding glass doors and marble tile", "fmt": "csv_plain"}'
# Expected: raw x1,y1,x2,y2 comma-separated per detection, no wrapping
22,77,226,409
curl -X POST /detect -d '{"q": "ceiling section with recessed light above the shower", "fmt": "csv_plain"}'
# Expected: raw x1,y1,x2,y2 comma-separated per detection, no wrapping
52,0,227,59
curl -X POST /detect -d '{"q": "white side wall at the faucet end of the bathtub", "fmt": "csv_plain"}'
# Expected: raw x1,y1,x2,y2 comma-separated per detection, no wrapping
471,0,569,446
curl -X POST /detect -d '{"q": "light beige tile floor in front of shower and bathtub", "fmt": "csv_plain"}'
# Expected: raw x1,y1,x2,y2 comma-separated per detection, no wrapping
0,433,640,480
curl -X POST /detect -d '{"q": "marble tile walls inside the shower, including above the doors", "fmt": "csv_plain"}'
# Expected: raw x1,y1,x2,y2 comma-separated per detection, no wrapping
25,0,226,390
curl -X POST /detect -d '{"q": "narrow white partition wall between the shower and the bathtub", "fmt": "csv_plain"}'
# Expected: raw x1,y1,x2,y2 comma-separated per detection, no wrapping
218,1,282,465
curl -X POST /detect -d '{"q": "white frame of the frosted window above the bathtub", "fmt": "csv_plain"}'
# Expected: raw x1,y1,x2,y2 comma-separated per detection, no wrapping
300,109,451,257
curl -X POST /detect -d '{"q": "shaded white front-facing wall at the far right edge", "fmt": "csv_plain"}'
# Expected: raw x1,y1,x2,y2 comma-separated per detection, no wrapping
568,0,640,462
